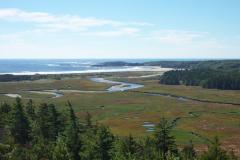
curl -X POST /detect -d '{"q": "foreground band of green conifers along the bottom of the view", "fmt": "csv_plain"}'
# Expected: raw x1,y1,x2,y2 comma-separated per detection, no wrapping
0,98,237,160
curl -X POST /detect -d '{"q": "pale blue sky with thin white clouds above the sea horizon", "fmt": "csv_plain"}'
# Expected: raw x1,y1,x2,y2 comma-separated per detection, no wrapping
0,0,240,59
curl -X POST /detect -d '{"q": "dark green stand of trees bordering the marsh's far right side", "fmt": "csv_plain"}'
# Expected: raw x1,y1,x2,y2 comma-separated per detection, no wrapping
159,68,240,90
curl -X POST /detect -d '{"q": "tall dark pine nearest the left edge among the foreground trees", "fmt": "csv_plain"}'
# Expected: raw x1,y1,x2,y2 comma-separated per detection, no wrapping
11,98,30,145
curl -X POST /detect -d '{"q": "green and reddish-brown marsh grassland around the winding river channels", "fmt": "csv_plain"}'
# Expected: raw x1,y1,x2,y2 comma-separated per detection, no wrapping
0,72,240,153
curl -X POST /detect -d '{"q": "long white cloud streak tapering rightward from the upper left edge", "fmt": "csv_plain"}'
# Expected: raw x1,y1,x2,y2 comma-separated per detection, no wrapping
0,8,152,31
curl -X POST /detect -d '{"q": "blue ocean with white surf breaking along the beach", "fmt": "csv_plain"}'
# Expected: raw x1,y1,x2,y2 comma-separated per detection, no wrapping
0,59,160,75
